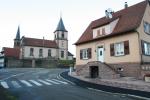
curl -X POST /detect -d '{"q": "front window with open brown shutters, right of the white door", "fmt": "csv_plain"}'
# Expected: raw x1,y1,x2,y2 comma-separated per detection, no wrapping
110,41,130,56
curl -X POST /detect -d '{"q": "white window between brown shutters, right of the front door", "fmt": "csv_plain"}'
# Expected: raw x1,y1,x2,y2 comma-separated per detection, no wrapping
114,42,125,56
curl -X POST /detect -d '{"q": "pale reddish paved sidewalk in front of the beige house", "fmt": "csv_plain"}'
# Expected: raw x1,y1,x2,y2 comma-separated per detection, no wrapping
70,72,150,92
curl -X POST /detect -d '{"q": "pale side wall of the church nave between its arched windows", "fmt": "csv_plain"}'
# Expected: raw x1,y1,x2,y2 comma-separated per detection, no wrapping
24,46,58,58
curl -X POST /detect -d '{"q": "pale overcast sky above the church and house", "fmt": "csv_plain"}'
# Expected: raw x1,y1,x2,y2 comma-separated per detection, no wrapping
0,0,143,54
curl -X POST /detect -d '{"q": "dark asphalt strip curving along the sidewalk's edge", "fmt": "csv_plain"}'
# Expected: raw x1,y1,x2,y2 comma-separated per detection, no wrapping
60,71,150,100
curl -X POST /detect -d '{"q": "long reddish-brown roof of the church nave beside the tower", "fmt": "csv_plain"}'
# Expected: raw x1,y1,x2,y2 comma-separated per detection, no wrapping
22,37,58,48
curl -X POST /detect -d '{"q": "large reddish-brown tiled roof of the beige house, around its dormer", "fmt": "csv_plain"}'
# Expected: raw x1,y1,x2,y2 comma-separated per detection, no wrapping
75,0,147,45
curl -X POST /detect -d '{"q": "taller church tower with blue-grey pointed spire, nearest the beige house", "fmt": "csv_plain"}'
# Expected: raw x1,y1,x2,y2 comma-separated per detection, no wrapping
54,18,68,60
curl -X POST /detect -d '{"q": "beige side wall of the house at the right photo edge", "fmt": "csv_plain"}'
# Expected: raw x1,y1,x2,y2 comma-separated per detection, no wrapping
137,5,150,62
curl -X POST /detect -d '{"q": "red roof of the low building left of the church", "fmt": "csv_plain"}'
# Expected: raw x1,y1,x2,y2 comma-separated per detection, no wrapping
3,47,20,58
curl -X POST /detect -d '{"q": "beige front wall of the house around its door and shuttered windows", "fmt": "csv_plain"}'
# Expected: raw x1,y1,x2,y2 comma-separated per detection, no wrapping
76,32,141,65
